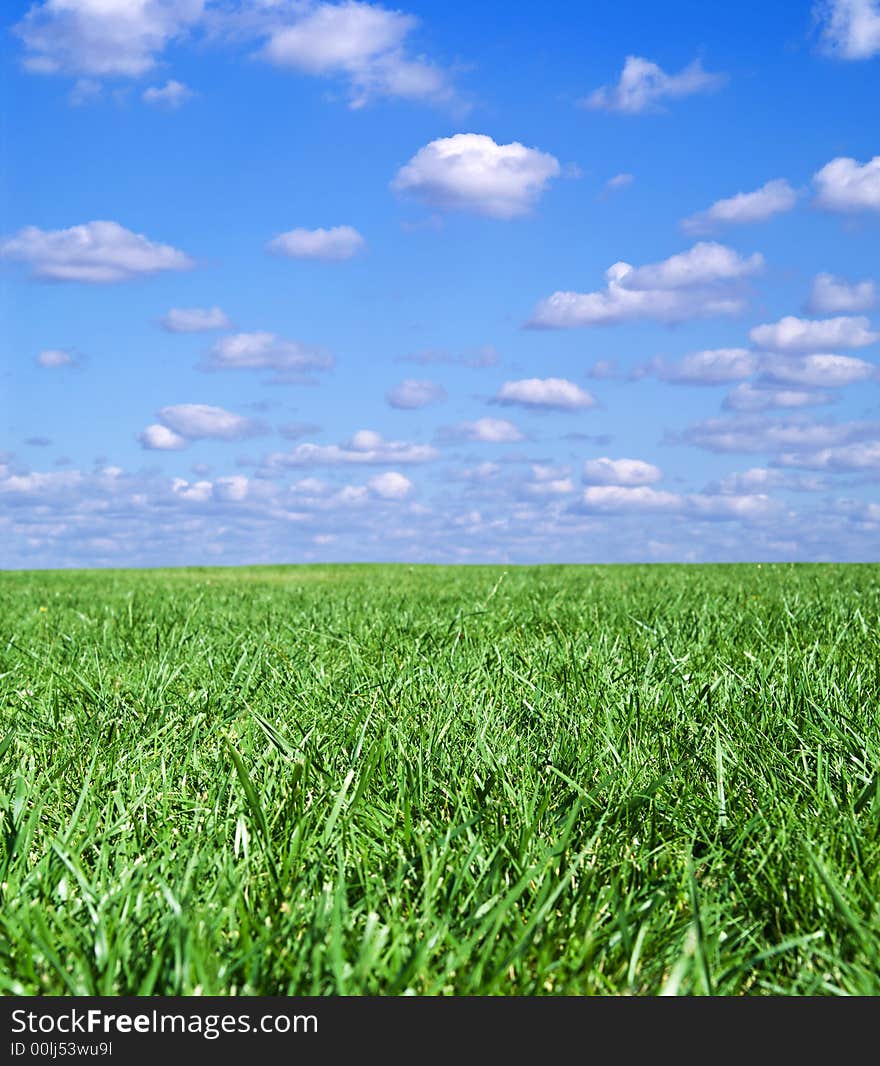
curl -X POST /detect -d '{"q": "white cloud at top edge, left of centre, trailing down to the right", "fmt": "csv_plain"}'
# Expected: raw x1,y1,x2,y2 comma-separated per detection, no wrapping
260,2,454,108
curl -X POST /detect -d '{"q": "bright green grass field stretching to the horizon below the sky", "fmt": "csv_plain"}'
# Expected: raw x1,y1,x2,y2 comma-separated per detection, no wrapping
0,564,880,996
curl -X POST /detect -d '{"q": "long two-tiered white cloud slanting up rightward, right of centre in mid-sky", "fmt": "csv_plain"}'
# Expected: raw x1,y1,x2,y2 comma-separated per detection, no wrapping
528,241,764,329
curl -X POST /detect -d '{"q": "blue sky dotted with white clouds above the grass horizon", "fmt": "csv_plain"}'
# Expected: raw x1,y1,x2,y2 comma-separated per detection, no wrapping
0,0,880,568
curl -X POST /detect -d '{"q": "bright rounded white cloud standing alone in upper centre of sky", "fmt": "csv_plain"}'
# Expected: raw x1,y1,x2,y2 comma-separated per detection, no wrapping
391,133,561,219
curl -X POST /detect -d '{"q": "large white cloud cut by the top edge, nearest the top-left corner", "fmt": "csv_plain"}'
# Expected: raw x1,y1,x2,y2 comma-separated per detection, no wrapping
14,0,205,78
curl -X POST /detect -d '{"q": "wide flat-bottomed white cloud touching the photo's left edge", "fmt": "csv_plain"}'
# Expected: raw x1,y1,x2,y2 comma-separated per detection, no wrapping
0,222,194,284
